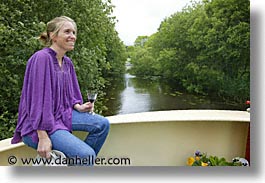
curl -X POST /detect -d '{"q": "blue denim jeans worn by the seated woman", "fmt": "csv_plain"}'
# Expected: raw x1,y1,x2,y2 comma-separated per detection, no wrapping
22,110,109,165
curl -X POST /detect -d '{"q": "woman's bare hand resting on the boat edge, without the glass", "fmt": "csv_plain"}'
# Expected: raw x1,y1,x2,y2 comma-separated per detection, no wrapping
37,130,52,159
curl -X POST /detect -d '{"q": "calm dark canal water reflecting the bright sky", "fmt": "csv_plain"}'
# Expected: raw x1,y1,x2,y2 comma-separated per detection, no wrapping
103,74,245,116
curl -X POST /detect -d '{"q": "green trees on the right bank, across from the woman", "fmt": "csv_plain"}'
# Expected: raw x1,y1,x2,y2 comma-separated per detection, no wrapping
129,0,250,103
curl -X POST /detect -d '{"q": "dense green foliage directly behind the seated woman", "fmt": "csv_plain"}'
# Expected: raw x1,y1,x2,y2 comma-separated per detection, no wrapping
0,0,126,140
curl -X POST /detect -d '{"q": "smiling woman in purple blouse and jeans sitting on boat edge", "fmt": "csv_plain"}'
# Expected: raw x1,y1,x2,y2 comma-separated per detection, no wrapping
12,16,109,165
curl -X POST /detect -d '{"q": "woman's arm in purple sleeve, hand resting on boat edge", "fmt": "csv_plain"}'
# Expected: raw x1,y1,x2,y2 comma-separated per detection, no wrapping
24,51,54,158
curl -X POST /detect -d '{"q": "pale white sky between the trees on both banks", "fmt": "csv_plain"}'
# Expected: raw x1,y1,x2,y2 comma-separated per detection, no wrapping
111,0,190,45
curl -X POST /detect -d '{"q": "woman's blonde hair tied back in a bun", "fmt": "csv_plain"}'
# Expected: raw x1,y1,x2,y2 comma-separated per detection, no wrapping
39,16,77,46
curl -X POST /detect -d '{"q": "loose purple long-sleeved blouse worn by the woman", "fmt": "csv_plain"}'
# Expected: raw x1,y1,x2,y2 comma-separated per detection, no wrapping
11,48,83,144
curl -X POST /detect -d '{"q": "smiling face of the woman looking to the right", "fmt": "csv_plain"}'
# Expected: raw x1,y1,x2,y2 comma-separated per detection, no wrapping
52,22,76,52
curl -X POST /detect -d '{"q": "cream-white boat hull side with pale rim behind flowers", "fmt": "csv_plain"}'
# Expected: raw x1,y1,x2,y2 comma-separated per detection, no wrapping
0,110,250,166
